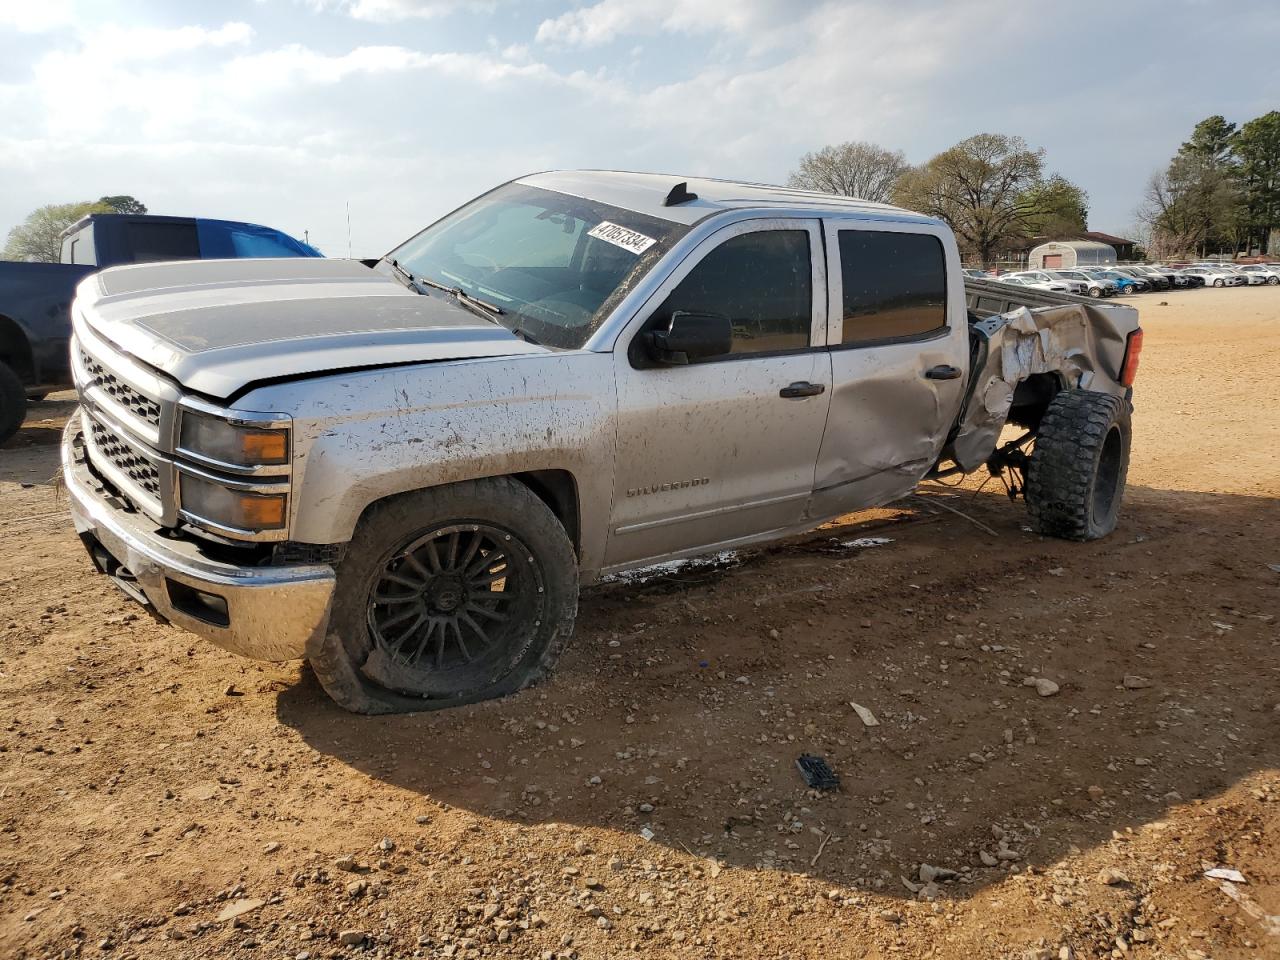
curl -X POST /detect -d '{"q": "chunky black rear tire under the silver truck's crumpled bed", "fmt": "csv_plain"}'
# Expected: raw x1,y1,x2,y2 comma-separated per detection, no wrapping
1027,390,1130,540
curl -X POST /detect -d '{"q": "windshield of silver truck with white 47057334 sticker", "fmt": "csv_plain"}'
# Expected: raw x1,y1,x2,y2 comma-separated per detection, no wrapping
385,183,689,348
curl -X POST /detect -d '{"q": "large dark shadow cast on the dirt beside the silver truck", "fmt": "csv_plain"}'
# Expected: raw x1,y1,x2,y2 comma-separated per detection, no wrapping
276,488,1280,897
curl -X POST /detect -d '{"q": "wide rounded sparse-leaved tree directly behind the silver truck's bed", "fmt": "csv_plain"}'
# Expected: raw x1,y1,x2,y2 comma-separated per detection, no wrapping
893,133,1044,262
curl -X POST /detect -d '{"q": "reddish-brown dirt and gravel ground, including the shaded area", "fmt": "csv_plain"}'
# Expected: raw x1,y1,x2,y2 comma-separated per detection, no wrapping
0,288,1280,960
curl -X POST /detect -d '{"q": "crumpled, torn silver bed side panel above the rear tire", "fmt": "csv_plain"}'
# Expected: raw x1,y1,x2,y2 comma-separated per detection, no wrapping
952,303,1138,471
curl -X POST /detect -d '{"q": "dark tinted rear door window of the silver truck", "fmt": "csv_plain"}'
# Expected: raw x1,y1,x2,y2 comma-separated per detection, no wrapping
840,230,947,343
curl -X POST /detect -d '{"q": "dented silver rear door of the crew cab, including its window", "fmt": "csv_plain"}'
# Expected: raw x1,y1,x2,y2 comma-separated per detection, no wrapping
812,220,969,518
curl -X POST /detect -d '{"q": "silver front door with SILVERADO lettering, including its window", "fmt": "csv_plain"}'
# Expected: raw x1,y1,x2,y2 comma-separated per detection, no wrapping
605,219,831,567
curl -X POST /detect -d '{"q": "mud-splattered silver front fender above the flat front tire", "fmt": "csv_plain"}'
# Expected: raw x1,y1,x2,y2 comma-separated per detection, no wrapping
250,351,617,571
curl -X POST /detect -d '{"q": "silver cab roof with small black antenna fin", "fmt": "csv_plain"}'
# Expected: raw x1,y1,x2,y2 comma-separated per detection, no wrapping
516,170,938,225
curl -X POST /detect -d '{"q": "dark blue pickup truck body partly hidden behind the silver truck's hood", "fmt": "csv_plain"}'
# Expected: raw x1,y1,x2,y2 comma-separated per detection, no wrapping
0,214,323,443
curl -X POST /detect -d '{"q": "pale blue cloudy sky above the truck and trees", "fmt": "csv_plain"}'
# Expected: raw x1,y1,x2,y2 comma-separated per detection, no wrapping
0,0,1280,256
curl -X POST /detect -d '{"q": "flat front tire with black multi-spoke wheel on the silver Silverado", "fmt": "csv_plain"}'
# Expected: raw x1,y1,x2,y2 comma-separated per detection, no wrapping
307,477,577,713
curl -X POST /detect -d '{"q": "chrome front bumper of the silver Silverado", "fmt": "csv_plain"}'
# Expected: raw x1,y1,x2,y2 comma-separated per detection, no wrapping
61,416,337,660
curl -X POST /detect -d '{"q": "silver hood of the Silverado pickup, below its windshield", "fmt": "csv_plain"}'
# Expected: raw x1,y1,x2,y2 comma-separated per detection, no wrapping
73,257,547,398
